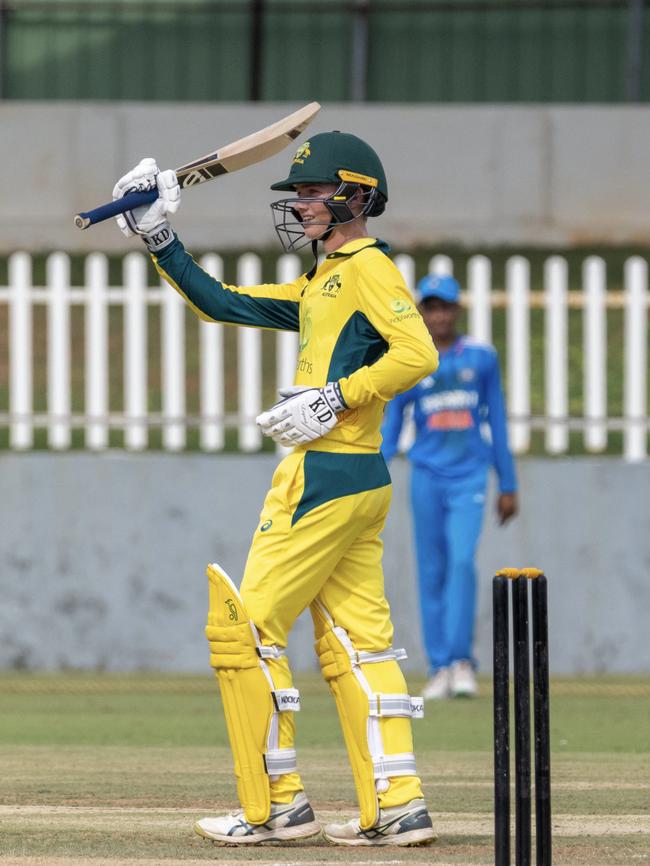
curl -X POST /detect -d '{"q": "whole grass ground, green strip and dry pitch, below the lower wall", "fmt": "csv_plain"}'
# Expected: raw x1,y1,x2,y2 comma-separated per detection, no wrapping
0,674,650,866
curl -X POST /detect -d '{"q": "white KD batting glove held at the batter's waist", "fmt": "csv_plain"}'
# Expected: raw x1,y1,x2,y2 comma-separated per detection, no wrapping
257,382,348,447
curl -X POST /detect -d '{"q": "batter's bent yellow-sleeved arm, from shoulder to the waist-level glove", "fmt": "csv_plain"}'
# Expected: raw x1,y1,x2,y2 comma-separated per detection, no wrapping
339,253,438,408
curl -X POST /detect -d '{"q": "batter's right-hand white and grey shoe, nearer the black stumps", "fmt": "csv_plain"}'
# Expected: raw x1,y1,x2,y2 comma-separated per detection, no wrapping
323,800,436,846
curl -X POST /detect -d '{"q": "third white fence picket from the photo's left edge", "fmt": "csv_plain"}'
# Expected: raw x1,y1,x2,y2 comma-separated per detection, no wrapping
84,253,108,451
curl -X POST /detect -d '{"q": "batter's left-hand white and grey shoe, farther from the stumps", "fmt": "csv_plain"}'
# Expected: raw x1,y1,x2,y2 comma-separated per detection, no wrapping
194,791,321,845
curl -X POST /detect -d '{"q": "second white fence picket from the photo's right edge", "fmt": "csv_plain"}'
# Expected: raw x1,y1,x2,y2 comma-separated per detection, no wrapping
582,256,607,452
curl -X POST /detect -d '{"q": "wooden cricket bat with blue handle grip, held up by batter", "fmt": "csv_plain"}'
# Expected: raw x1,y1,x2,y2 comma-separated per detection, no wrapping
74,102,320,229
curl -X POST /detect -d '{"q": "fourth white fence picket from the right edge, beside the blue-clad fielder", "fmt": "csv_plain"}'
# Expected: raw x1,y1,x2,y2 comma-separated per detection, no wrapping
506,256,530,454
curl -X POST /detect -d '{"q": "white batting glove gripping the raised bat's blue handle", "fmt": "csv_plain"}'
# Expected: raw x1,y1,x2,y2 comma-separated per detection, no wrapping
113,157,181,252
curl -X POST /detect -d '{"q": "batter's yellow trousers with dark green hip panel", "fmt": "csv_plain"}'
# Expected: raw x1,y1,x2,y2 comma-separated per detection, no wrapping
240,451,422,808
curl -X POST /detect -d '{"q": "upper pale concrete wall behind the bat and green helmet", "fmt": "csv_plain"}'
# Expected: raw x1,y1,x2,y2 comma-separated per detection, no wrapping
0,102,650,253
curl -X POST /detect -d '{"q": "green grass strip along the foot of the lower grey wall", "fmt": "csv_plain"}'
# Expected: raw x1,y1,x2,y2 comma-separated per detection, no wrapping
0,674,650,754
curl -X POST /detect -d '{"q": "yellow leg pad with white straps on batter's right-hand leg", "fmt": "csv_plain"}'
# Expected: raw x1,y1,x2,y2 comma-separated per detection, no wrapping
312,602,422,830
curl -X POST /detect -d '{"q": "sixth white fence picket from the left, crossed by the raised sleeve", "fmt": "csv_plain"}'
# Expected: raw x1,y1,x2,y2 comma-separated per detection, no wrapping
199,253,224,451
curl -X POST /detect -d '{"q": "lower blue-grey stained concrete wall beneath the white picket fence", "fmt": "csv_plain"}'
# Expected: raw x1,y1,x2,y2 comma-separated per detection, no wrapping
0,453,650,672
